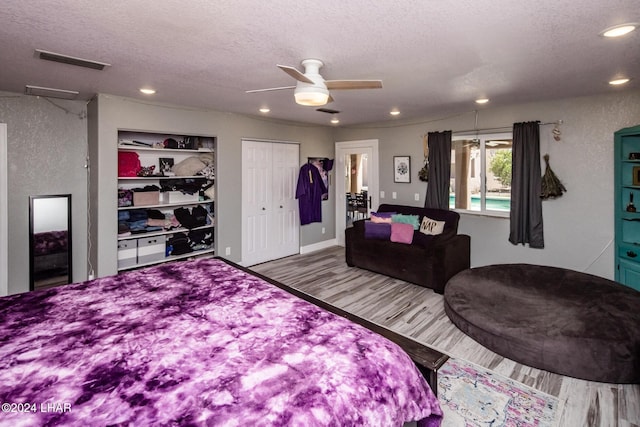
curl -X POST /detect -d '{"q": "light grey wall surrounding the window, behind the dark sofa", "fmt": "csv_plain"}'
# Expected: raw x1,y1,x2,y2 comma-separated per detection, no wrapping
336,91,640,279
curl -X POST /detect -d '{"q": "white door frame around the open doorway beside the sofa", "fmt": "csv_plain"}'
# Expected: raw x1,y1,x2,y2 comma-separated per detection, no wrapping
335,139,380,246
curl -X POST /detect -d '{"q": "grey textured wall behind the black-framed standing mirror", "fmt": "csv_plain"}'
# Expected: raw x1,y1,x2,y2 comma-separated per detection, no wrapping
0,93,87,294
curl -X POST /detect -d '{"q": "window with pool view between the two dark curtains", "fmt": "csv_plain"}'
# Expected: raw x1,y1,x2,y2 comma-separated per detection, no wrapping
449,133,513,216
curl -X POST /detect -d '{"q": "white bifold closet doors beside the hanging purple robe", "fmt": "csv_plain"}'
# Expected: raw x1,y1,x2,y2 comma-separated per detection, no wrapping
242,140,300,266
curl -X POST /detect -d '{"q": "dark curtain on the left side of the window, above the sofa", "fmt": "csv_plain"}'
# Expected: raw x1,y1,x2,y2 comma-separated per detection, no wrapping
424,130,451,210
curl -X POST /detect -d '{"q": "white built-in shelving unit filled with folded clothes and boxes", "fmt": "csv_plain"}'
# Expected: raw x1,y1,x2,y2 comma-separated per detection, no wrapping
117,131,216,271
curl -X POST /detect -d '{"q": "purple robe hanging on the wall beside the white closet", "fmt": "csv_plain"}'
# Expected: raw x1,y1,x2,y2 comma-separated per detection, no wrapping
296,163,328,225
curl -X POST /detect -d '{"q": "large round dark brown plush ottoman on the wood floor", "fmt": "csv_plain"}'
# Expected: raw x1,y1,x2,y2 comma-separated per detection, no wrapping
444,264,640,383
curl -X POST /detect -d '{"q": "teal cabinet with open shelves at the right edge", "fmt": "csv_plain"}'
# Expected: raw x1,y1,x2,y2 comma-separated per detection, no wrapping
614,126,640,290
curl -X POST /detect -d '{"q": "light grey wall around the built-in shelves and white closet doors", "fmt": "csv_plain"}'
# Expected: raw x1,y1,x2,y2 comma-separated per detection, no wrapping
88,94,335,277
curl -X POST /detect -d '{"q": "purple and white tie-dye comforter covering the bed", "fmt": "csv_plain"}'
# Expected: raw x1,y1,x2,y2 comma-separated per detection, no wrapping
0,259,442,427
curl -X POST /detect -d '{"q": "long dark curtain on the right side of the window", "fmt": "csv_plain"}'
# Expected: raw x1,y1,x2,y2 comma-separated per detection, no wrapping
509,122,544,249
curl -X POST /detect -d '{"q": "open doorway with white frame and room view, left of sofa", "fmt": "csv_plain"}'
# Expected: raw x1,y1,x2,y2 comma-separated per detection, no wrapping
335,139,380,246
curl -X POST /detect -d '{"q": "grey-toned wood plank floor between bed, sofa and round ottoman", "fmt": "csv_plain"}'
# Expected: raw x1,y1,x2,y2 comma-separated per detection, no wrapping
250,246,640,427
